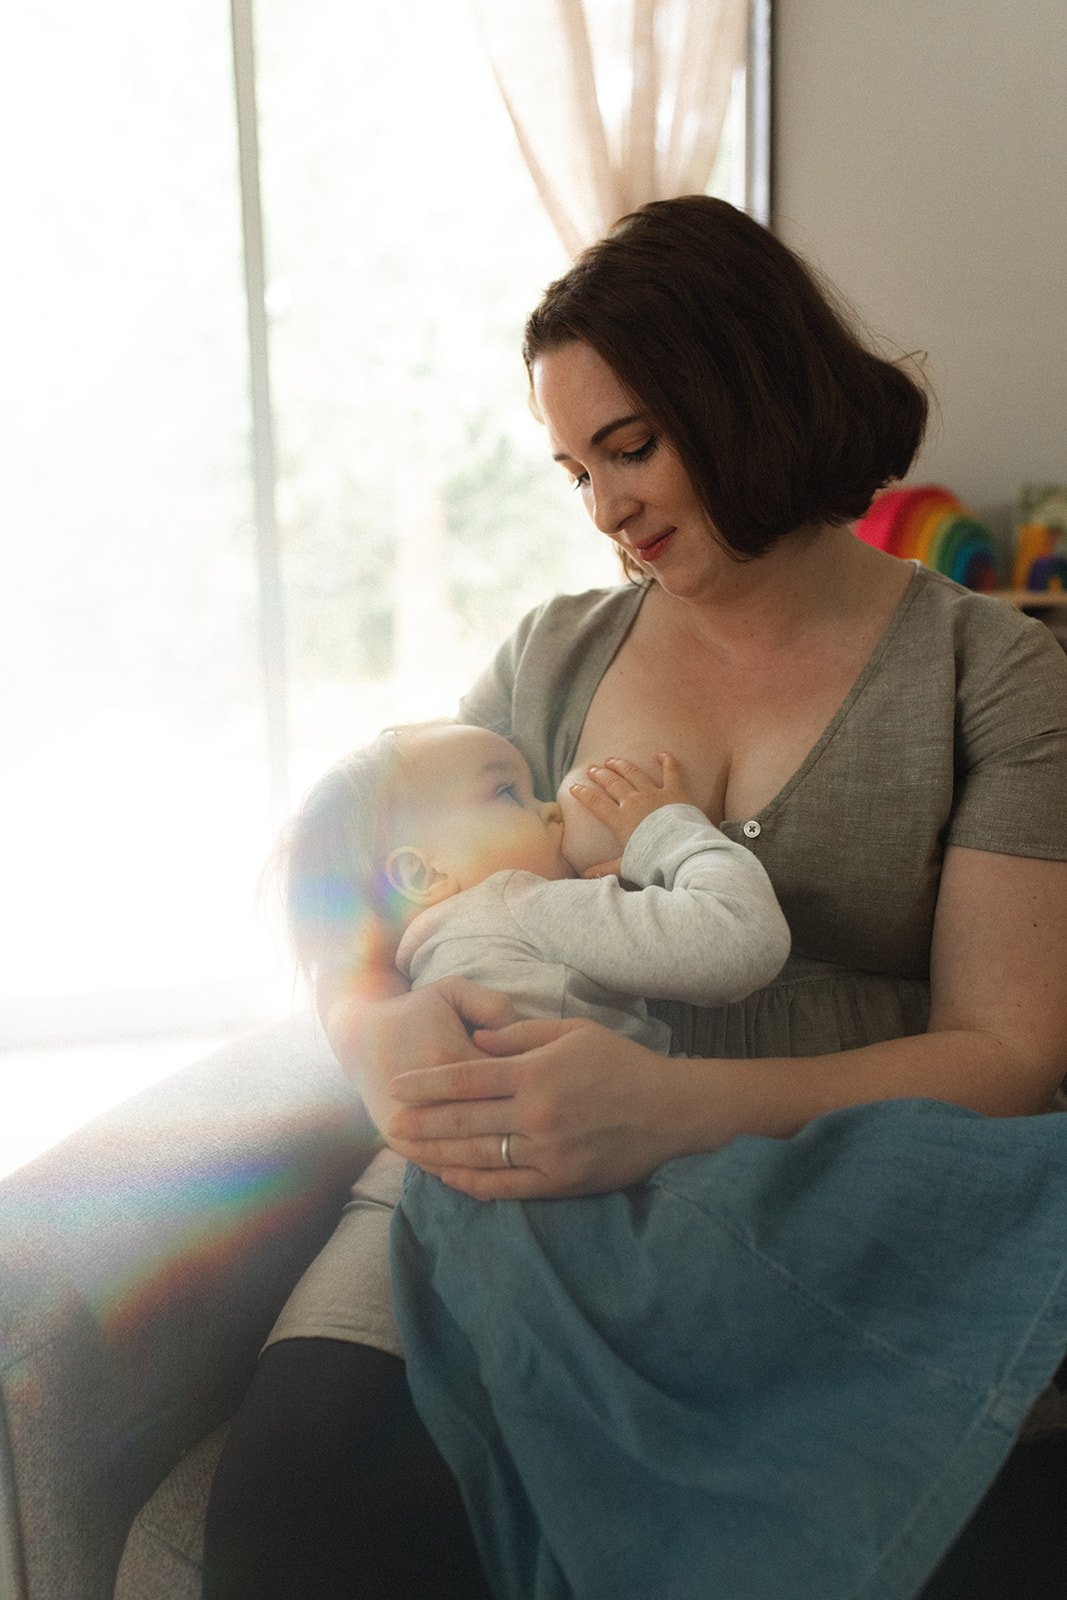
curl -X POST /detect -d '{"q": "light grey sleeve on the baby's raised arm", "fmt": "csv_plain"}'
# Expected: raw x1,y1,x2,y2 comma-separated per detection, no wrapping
506,805,790,1006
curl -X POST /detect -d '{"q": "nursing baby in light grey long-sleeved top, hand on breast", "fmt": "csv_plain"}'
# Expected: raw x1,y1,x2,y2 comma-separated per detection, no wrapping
286,723,789,1053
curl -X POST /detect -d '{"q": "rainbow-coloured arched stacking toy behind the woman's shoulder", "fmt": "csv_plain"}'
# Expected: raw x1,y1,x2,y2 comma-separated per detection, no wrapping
856,483,1000,592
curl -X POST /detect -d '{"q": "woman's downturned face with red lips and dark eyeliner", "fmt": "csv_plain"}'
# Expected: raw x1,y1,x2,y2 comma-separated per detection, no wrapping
533,339,721,598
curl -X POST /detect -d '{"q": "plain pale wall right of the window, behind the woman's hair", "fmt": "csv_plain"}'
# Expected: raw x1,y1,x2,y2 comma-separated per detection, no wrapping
774,0,1067,533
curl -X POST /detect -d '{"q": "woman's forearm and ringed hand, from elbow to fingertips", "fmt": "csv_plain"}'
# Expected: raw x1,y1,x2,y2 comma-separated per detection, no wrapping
379,998,1067,1200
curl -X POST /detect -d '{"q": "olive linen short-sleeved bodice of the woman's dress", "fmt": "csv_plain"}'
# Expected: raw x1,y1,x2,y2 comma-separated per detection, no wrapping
459,566,1067,1058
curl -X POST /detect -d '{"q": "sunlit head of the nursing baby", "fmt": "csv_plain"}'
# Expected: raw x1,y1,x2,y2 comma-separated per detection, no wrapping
283,723,574,973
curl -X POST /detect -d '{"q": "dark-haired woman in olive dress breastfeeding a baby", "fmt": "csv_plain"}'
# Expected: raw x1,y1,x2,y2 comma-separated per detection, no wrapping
205,198,1067,1600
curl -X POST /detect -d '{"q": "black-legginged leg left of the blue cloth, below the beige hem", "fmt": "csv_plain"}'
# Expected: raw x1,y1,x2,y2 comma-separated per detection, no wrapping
203,1339,490,1600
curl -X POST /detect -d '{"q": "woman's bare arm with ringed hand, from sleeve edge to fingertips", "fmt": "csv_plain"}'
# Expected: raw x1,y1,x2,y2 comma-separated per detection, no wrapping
389,848,1067,1198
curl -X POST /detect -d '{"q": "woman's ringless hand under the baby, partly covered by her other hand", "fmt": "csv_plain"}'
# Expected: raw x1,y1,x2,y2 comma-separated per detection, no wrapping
323,978,515,1149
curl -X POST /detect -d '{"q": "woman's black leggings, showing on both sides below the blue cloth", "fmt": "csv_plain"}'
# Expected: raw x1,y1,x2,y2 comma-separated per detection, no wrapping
203,1339,1067,1600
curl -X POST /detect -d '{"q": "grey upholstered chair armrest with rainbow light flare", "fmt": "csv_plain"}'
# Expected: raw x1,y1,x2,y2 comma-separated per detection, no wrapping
0,1018,378,1600
